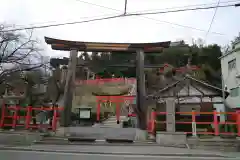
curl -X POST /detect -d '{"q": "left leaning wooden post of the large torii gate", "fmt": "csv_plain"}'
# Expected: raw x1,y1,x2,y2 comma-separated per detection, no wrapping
60,49,78,127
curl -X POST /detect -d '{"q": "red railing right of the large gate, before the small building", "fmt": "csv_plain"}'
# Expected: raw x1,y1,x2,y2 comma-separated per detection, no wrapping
148,111,240,136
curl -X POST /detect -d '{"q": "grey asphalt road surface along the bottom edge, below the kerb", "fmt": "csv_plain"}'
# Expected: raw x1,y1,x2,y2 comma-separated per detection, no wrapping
0,150,239,160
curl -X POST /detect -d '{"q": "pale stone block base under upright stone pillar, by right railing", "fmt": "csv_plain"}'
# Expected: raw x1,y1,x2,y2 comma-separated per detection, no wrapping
156,132,187,146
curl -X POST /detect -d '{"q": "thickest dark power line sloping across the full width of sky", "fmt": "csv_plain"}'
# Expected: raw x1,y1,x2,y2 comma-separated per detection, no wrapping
0,3,240,32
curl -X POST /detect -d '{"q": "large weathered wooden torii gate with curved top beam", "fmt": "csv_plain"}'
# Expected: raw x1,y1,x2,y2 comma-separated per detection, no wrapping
45,37,171,130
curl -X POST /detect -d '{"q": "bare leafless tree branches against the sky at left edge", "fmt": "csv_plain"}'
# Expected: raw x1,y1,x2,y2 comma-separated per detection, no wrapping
0,25,44,84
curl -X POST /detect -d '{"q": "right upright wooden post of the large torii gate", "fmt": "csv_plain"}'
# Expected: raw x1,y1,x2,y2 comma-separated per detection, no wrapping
136,50,147,130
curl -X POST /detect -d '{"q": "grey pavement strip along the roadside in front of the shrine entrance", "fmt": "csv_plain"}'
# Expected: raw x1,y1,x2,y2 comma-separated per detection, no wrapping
0,144,240,159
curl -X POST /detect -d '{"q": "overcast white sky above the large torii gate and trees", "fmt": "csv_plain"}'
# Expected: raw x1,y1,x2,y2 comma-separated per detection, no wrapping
0,0,240,56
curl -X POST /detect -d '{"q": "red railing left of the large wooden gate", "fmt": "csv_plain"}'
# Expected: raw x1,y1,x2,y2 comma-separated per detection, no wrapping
0,105,63,131
